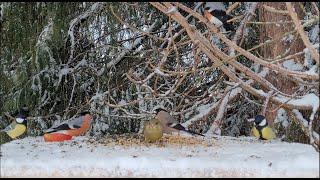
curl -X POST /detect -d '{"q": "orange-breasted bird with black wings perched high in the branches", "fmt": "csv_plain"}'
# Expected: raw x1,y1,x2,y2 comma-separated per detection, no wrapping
204,2,234,31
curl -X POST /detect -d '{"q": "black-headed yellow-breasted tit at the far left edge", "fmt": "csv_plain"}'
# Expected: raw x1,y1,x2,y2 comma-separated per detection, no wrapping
0,107,29,144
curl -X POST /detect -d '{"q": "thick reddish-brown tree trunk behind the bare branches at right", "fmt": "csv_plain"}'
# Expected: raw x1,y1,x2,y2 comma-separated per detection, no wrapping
259,2,304,124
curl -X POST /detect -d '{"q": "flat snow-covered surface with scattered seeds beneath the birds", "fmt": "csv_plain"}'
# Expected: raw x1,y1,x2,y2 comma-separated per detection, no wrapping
0,137,319,177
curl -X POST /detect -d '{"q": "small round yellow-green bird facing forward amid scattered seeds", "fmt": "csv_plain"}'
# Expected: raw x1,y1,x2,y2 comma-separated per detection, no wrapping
143,119,163,142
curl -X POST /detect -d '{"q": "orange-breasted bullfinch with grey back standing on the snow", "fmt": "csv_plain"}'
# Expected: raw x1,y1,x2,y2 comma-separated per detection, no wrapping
45,112,92,136
